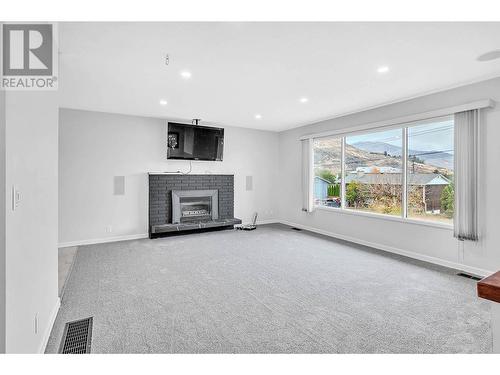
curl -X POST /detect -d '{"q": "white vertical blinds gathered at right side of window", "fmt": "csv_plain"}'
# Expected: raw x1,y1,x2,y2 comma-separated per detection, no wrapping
454,109,479,241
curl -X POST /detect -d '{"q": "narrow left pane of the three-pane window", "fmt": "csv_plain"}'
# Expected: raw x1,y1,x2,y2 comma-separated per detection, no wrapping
313,137,342,208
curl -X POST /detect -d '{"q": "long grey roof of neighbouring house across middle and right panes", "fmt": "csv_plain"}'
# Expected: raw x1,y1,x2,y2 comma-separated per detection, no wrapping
345,173,451,186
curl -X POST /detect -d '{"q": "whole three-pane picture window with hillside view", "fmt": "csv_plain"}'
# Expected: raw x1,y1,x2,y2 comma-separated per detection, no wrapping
313,116,454,224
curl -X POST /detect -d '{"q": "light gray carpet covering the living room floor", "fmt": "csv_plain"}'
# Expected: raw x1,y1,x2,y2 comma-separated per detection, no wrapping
47,225,492,353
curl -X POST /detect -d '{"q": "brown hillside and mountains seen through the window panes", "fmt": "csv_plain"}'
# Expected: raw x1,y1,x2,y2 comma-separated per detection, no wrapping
314,139,453,175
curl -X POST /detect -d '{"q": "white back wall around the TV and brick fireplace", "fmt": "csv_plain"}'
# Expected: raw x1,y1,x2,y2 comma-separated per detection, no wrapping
59,109,281,246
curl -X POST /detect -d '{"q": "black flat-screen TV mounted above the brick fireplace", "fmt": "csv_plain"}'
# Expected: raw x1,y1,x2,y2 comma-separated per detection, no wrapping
167,122,224,161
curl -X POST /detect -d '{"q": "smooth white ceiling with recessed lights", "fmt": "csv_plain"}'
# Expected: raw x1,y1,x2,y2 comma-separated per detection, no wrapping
59,23,500,131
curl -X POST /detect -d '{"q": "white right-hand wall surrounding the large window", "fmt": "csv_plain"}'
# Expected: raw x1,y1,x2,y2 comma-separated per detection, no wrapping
278,78,500,273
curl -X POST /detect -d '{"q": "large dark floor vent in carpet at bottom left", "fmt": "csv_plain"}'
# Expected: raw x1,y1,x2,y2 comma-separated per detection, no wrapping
59,318,92,354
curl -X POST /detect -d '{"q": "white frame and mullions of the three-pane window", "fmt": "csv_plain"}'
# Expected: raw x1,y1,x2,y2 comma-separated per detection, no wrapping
311,115,455,230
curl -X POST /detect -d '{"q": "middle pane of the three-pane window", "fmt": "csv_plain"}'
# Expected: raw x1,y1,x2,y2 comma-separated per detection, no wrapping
345,129,403,216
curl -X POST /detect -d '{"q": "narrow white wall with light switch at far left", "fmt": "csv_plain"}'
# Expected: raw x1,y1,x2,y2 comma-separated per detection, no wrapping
4,91,59,353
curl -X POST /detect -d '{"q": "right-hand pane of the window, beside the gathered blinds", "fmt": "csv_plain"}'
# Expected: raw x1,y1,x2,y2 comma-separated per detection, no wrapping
407,117,454,224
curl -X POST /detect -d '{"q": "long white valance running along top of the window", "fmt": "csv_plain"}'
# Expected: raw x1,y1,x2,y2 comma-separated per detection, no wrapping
299,99,495,140
